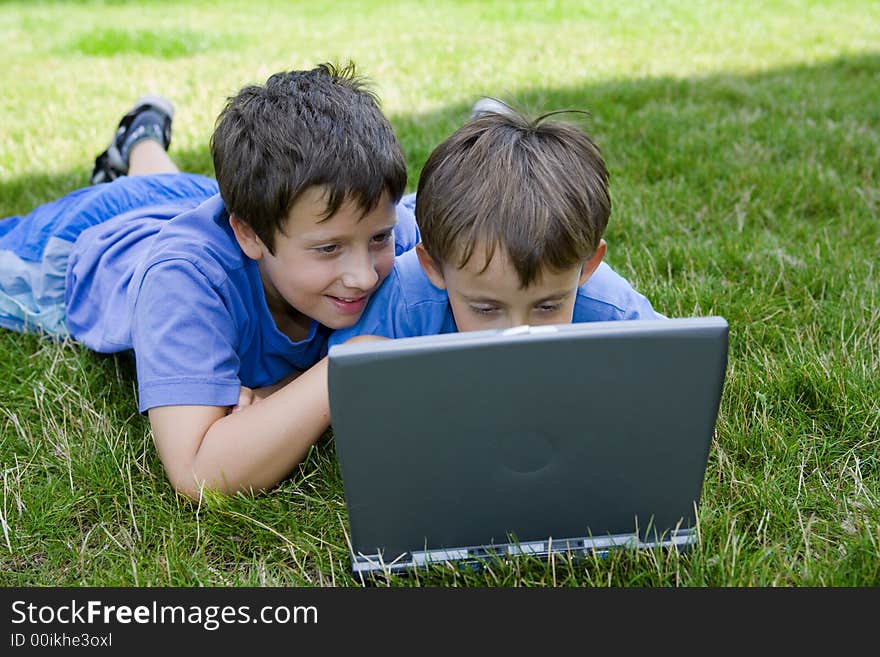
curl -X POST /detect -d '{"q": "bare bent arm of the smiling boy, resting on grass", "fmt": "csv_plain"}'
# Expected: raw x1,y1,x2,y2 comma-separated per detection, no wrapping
148,358,330,499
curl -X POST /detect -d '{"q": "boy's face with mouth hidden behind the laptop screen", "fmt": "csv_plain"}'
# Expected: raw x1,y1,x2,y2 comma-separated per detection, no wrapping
418,241,605,331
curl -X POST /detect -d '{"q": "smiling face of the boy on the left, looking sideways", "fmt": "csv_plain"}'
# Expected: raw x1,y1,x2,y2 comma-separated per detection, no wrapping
232,187,397,340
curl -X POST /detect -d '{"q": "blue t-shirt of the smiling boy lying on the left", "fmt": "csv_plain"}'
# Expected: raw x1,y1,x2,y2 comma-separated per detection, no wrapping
67,187,419,412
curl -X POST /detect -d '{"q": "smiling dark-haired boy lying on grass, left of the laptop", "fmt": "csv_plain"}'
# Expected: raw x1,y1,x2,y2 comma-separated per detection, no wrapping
0,65,418,498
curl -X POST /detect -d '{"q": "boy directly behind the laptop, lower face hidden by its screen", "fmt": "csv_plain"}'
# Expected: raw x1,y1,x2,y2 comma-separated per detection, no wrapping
331,101,663,345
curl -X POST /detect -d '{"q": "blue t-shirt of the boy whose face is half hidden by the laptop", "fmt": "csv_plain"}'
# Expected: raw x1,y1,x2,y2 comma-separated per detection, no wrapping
330,250,663,346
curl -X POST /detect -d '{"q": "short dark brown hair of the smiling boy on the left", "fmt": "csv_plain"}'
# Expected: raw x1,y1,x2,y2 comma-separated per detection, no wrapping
211,63,406,252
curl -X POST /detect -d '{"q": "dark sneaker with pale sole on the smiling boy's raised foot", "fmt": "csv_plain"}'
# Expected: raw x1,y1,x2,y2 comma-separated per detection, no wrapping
89,96,174,185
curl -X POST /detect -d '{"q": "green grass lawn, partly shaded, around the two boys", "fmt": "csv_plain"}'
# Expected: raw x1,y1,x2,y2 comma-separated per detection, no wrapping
0,0,880,586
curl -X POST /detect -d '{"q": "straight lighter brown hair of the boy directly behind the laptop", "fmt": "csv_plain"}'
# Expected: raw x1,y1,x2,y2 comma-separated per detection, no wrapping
415,101,611,287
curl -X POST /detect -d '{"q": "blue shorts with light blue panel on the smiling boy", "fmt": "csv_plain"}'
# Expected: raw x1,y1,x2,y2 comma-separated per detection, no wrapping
0,173,218,338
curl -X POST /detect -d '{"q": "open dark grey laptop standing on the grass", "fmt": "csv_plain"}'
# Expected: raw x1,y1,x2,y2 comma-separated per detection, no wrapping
329,317,728,574
